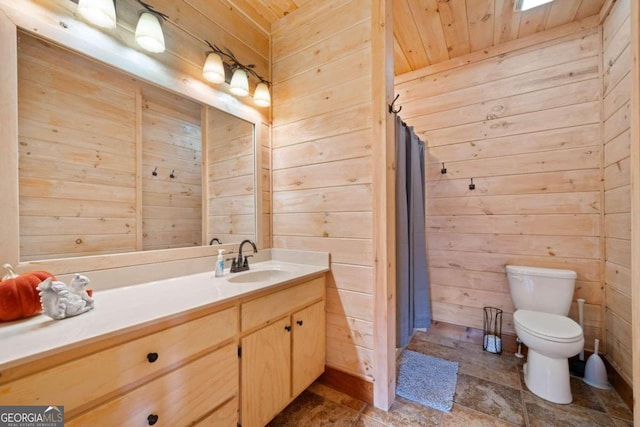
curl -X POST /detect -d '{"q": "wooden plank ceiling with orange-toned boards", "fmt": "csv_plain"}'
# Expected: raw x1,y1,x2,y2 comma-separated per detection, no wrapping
230,0,605,75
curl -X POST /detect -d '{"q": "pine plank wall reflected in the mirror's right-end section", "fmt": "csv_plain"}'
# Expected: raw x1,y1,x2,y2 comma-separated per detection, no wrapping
207,108,256,243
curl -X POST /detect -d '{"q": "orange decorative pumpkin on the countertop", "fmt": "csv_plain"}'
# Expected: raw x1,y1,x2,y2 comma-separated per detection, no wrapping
0,264,56,322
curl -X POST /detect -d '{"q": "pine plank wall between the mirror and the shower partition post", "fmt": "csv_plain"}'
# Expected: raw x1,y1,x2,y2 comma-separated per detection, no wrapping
272,0,374,381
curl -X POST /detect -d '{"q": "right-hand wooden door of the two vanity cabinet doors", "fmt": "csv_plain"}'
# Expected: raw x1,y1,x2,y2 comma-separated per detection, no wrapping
292,301,326,396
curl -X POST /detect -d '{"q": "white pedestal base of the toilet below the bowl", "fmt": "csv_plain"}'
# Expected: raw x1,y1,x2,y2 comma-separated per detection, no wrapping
524,348,573,404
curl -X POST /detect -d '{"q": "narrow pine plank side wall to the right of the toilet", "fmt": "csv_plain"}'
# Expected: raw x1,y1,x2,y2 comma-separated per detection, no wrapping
602,0,633,384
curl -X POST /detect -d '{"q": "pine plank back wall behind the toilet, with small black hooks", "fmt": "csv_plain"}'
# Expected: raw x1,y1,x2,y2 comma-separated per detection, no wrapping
396,22,603,342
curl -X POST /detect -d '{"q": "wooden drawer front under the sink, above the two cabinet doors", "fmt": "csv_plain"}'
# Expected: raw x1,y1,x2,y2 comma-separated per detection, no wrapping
241,276,325,332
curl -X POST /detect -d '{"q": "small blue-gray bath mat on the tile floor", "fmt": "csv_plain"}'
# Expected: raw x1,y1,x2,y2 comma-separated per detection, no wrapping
396,350,458,412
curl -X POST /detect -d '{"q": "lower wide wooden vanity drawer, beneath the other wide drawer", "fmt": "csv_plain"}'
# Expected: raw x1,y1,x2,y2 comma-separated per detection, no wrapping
65,344,239,427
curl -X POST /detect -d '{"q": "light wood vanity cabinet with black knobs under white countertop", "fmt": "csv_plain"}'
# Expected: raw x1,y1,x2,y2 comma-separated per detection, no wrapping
0,274,326,427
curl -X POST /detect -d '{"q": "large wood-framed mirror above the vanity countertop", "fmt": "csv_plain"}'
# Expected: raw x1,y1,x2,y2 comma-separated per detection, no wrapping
0,10,269,274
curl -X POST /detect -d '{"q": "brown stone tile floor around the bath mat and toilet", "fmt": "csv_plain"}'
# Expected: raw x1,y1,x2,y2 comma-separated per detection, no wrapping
269,332,633,427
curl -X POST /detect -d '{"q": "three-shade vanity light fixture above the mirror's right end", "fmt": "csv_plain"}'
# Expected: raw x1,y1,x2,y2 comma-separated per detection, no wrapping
202,40,271,107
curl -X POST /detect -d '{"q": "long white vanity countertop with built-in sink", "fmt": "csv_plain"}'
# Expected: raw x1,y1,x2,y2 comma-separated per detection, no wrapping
0,254,329,371
